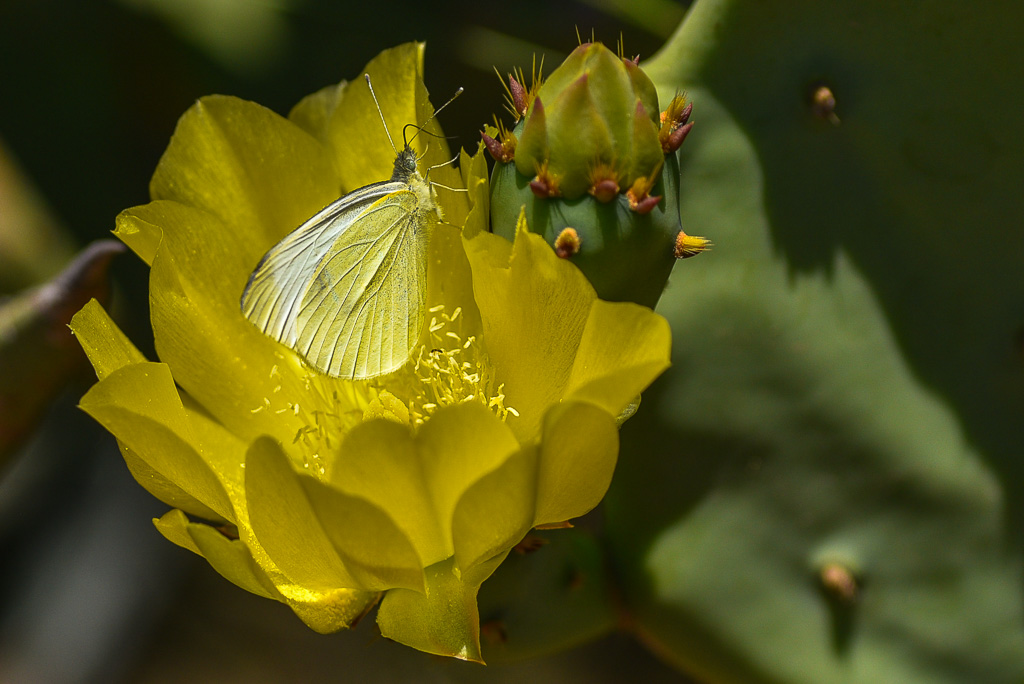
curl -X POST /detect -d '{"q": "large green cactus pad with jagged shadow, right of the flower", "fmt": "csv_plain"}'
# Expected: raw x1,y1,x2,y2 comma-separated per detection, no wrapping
606,0,1024,684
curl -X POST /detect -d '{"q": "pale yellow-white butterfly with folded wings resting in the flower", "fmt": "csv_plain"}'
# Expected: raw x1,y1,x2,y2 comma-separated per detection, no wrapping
241,75,462,380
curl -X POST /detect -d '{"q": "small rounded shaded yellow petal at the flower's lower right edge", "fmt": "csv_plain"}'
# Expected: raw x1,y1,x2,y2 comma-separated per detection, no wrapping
534,401,618,525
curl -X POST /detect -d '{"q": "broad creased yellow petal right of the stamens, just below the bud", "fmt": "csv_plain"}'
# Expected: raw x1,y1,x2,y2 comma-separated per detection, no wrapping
465,215,672,441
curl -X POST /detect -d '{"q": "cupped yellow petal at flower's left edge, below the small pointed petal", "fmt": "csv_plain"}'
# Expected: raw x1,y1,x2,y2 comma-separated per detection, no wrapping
81,364,236,522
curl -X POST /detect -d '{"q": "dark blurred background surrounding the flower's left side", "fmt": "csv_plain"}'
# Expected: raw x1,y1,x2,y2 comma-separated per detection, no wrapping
0,0,686,682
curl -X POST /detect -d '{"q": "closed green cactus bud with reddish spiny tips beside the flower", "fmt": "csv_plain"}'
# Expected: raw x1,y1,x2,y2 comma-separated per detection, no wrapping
483,43,708,306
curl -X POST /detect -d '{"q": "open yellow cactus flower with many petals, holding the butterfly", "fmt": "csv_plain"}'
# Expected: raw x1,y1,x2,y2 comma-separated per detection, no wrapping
73,44,670,660
